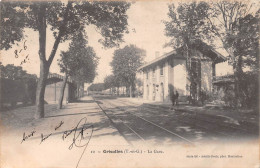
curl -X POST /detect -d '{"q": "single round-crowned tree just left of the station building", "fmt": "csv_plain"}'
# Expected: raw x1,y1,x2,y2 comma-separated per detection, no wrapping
111,45,145,97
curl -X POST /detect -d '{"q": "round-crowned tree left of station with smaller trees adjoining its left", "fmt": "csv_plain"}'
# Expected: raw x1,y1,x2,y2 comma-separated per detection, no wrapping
104,45,145,97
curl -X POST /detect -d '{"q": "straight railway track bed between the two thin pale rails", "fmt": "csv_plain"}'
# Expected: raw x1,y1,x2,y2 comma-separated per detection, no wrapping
93,96,195,146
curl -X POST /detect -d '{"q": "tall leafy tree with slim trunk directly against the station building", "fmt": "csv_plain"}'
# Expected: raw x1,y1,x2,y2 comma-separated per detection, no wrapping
164,2,209,99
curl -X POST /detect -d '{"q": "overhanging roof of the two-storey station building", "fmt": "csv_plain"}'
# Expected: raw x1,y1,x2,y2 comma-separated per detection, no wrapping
138,40,226,71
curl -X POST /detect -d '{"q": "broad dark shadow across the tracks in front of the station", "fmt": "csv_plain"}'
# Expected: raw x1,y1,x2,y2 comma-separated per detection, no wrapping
98,101,258,144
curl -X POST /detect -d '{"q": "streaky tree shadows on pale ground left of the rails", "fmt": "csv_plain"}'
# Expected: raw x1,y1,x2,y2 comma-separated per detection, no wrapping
1,100,125,143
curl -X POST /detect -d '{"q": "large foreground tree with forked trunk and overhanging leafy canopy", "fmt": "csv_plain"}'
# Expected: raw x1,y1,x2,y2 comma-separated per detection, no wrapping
1,1,130,118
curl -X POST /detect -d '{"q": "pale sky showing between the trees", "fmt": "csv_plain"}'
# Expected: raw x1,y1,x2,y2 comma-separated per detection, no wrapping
1,1,233,83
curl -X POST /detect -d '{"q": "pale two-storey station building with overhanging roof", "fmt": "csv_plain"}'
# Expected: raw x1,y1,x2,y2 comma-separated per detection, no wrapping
139,41,226,101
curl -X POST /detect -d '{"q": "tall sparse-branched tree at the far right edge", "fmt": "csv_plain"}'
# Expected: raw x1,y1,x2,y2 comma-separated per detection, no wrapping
201,1,259,107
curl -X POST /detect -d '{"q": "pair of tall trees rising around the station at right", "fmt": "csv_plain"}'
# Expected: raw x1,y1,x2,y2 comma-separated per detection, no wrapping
164,1,260,106
